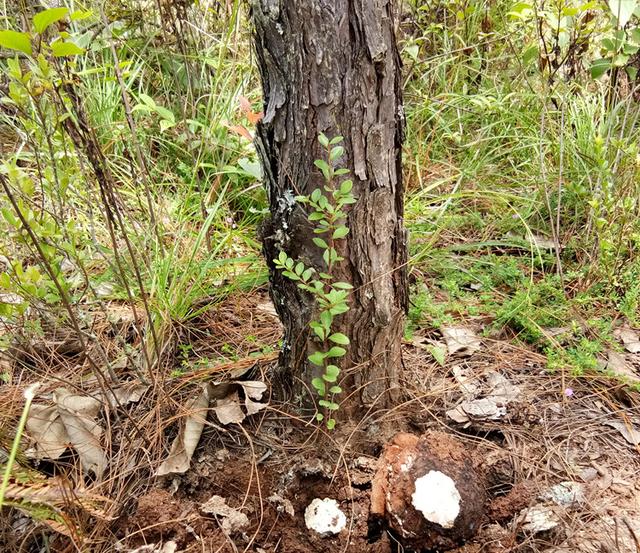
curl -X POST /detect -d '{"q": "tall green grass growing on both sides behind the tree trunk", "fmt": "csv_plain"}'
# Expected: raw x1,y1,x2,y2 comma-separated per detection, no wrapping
2,0,640,384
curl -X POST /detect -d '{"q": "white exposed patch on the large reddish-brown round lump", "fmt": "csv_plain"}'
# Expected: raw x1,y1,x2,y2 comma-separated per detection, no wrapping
411,470,460,528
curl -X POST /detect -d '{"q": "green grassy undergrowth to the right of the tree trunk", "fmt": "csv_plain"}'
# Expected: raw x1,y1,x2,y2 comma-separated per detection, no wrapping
405,2,640,374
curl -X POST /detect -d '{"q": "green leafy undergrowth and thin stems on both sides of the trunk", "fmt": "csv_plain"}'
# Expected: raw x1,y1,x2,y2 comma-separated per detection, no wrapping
0,0,640,544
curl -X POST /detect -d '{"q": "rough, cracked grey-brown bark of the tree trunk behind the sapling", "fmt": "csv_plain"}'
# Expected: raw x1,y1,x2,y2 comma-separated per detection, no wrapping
251,0,407,406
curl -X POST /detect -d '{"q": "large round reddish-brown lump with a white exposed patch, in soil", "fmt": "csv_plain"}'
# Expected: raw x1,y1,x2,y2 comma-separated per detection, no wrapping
370,432,486,551
